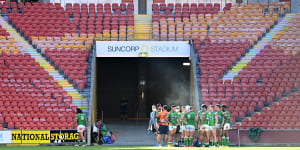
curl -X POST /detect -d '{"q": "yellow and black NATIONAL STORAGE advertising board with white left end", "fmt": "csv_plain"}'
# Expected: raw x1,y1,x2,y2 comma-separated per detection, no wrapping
0,129,78,144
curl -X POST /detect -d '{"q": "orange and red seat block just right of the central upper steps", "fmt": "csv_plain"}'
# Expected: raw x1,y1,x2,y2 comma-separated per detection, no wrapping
152,3,231,41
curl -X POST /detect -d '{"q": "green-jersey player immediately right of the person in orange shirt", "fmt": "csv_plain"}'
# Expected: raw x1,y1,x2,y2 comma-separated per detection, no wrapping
168,105,180,147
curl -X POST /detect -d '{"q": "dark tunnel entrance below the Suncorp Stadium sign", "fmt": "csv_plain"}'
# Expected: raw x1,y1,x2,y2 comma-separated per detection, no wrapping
94,57,193,120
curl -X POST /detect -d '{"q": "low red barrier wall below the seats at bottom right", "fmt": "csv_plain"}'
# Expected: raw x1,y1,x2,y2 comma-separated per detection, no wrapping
229,129,300,146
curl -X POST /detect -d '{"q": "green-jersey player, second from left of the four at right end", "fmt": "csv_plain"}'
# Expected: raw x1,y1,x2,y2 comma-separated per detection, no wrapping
208,105,218,147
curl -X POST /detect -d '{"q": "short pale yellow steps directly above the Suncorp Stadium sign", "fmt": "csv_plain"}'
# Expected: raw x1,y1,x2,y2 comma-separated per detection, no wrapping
134,15,152,40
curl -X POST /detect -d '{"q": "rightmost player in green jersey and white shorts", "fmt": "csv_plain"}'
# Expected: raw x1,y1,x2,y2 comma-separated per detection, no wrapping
221,105,230,146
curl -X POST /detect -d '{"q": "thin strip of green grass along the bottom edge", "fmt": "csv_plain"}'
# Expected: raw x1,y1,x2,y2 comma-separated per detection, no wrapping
0,146,300,150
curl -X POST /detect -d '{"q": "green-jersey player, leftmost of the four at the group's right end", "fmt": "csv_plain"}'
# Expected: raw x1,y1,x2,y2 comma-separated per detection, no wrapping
199,105,210,146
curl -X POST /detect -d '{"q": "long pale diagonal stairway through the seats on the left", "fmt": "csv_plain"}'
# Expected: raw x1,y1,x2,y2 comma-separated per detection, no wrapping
0,16,88,112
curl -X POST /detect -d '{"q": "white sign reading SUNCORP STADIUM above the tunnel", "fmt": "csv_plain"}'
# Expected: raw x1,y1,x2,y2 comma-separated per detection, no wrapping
96,41,190,57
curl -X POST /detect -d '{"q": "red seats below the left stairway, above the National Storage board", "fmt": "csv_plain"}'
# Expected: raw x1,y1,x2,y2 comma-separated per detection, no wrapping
0,53,76,129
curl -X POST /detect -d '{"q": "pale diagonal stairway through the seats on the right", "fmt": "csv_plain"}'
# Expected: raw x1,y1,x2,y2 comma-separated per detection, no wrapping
222,13,296,80
